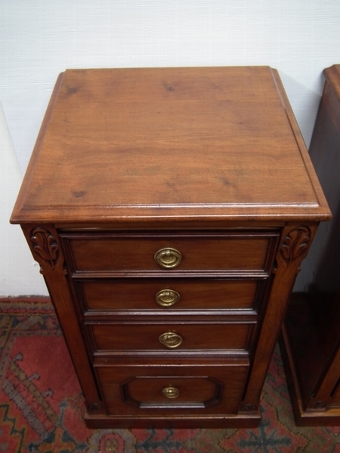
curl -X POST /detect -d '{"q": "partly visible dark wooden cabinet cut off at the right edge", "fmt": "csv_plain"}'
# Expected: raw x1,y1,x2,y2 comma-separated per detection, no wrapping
281,65,340,425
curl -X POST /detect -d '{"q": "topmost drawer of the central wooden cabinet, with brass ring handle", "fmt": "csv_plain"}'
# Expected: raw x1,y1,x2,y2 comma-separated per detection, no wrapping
60,232,279,272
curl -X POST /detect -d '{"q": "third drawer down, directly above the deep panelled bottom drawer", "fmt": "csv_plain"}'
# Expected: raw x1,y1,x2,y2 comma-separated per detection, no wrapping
86,321,256,354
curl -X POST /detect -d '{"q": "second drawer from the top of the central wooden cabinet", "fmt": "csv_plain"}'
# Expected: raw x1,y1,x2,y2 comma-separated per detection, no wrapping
76,278,266,311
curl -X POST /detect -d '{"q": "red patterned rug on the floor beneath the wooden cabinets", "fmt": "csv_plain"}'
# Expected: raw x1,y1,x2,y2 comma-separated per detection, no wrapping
0,298,340,453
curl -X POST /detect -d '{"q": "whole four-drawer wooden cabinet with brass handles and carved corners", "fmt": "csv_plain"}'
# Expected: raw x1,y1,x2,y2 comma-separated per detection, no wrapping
11,67,330,428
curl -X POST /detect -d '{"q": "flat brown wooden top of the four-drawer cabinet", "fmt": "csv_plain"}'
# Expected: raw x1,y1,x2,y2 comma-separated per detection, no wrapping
11,67,329,223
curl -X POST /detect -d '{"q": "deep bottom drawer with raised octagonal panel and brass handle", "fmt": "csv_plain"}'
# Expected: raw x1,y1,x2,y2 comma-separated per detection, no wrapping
96,361,249,416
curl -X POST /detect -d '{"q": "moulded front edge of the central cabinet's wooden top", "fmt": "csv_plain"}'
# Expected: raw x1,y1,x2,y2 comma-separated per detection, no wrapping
10,204,332,225
